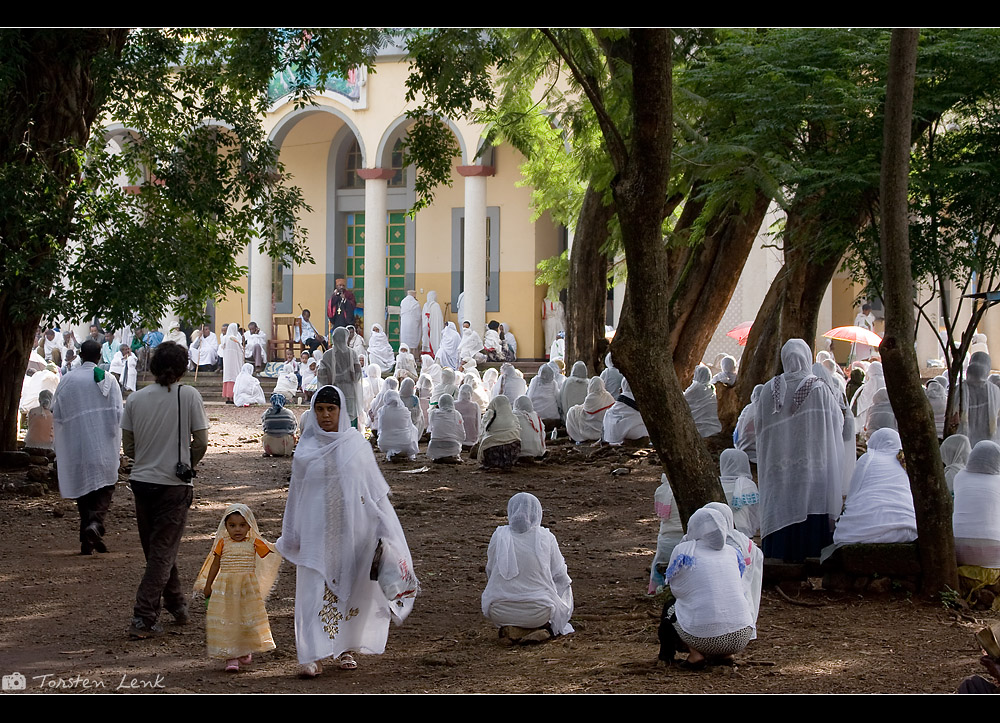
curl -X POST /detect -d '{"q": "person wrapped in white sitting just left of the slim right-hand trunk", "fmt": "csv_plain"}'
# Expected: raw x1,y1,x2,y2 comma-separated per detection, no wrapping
833,428,917,546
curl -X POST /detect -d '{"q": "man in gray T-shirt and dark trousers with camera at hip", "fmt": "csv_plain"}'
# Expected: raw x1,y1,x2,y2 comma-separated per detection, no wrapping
122,342,208,638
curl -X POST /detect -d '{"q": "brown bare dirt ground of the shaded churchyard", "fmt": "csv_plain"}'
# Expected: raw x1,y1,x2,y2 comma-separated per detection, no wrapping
0,405,992,693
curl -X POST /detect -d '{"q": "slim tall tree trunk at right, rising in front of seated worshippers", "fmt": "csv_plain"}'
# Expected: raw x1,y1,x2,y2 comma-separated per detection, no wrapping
880,29,958,595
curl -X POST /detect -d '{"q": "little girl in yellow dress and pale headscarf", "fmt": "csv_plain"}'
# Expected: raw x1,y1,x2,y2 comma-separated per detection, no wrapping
194,504,281,672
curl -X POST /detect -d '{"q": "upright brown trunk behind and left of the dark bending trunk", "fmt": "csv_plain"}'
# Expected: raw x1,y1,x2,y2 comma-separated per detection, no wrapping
566,184,614,376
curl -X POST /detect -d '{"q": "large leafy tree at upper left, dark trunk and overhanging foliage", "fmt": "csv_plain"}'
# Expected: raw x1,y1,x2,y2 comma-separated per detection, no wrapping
0,29,383,449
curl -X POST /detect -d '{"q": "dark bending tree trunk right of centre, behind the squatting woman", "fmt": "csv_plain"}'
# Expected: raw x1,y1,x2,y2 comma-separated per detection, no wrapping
600,30,725,524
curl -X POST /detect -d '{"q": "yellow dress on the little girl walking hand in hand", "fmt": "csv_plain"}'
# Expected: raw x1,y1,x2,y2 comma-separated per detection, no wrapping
205,539,274,660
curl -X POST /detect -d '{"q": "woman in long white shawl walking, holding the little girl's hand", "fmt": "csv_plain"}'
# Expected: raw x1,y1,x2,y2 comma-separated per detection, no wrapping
275,386,418,677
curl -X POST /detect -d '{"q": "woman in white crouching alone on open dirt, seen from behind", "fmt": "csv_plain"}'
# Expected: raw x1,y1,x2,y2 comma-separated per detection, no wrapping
482,492,573,642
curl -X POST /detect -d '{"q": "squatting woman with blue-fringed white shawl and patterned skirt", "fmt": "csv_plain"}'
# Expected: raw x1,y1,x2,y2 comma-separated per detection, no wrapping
660,510,752,670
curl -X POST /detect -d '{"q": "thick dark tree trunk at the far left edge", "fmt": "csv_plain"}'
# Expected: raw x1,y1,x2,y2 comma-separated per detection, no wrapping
0,29,128,450
